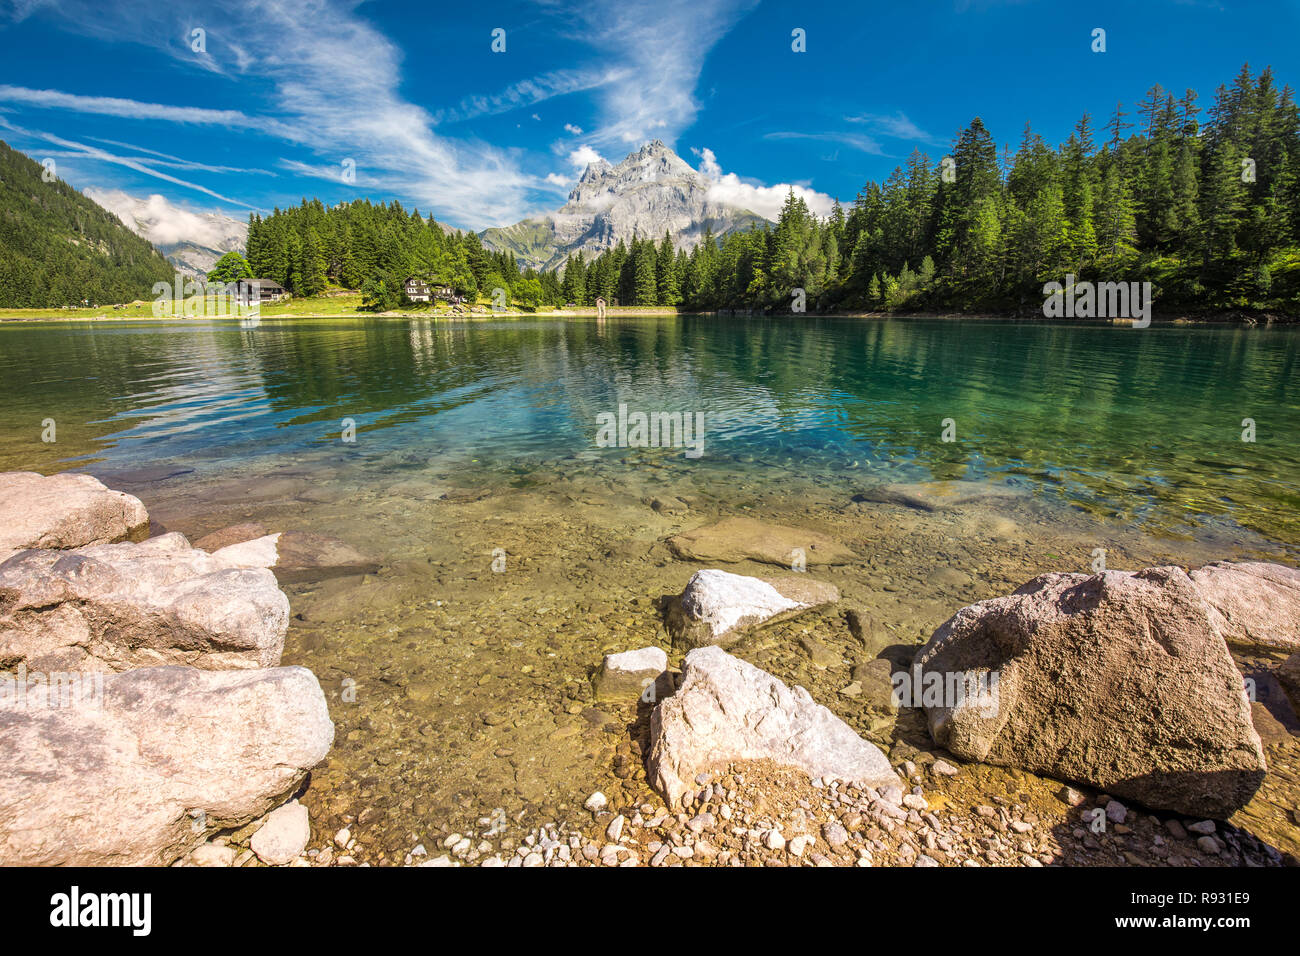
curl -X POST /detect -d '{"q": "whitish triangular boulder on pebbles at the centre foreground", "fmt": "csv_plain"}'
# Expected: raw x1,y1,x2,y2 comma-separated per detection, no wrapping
646,648,898,805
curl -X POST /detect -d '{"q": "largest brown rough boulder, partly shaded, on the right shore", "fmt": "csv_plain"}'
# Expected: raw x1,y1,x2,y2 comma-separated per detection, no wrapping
905,567,1265,819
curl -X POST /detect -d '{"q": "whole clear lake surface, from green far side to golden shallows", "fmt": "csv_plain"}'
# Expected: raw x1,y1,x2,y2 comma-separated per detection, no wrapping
0,316,1300,860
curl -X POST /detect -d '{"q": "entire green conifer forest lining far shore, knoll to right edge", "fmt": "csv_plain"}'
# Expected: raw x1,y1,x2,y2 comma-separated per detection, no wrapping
248,66,1300,313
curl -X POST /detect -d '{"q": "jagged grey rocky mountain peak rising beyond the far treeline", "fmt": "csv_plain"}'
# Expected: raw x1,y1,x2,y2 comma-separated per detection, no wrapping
480,139,767,271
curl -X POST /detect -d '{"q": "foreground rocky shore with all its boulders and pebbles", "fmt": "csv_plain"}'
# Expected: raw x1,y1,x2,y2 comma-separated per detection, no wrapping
0,473,1300,866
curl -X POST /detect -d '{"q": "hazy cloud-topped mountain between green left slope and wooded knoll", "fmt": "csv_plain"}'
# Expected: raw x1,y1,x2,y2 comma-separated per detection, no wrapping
86,189,248,278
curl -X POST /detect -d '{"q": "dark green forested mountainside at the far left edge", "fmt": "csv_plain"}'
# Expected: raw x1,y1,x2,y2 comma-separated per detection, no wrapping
0,142,176,308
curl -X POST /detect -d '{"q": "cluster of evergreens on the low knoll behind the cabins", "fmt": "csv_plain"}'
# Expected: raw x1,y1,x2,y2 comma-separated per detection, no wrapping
246,199,560,310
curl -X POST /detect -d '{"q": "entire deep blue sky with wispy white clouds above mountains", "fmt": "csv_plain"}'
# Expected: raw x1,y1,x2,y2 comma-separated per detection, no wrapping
0,0,1300,229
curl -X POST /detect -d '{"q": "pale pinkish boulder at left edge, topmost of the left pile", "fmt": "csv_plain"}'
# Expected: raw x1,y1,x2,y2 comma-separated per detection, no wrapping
0,471,150,561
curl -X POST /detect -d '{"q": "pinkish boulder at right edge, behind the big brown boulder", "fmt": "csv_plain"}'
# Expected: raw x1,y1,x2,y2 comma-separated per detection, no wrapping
1191,561,1300,650
